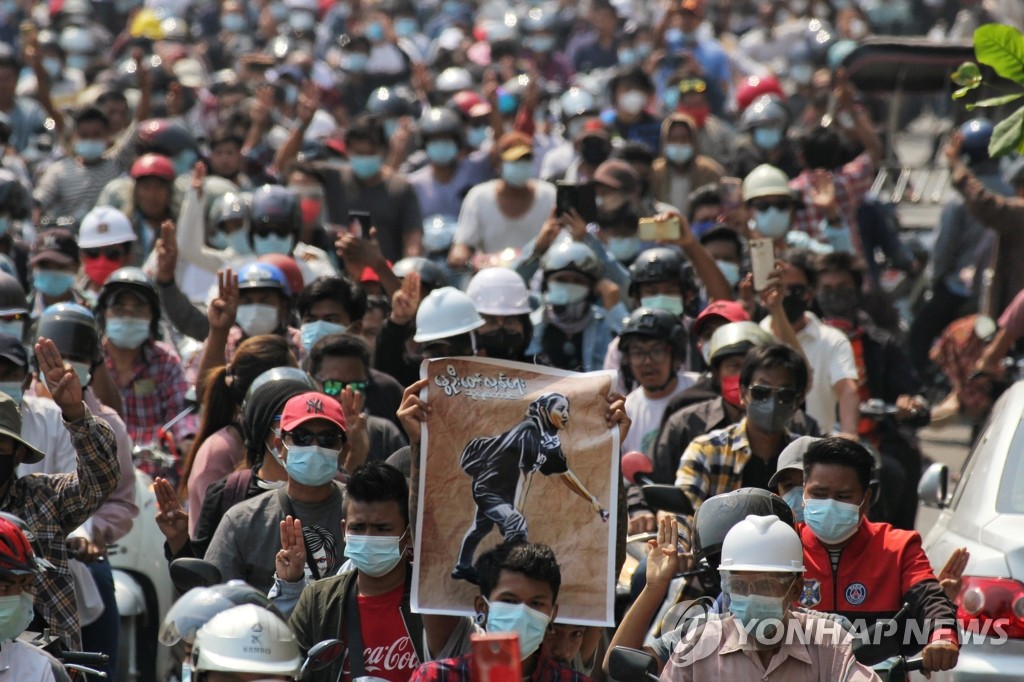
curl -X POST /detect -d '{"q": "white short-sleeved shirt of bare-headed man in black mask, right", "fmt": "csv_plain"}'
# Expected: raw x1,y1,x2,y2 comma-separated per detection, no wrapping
761,312,857,434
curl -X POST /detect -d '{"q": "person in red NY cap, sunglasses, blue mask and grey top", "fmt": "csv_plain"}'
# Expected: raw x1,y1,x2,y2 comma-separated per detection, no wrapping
206,392,366,591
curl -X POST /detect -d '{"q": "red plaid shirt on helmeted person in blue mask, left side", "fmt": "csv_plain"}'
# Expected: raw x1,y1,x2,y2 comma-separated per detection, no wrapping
103,339,196,448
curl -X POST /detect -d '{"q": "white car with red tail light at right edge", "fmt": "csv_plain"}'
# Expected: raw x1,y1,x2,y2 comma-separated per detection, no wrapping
919,381,1024,682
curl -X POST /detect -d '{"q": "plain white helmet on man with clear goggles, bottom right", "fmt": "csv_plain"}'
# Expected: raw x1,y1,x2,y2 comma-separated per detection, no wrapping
719,514,804,573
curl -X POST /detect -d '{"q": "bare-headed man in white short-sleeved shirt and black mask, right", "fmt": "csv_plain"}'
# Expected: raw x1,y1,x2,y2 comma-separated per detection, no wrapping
761,250,860,438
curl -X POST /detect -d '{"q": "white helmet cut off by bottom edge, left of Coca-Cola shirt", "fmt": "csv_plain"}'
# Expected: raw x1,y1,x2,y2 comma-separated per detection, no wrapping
191,604,302,678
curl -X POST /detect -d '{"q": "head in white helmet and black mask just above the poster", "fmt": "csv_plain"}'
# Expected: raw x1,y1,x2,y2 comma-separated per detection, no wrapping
466,267,534,361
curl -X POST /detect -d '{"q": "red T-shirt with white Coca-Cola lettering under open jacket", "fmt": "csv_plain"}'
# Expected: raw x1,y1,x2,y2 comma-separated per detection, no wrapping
344,584,420,682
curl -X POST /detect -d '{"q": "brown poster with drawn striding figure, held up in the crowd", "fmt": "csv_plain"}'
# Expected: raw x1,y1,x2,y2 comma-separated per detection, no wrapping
412,357,620,626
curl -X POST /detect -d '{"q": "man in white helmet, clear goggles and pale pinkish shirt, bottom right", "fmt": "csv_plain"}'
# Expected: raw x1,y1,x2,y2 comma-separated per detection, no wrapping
653,515,881,682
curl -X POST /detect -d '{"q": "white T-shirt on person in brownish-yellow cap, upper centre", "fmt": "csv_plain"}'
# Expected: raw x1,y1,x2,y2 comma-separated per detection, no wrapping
455,180,555,253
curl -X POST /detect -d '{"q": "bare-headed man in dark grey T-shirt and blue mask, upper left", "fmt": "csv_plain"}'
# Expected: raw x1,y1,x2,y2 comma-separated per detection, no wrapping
341,117,423,262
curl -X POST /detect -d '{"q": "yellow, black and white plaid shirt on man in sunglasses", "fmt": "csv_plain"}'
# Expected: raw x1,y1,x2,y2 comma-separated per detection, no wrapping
676,417,797,549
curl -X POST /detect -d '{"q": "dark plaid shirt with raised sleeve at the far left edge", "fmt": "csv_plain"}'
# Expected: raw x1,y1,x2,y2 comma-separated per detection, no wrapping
0,408,121,650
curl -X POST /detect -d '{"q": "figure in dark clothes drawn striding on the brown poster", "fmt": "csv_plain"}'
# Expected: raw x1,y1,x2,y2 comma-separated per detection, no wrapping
452,393,608,584
